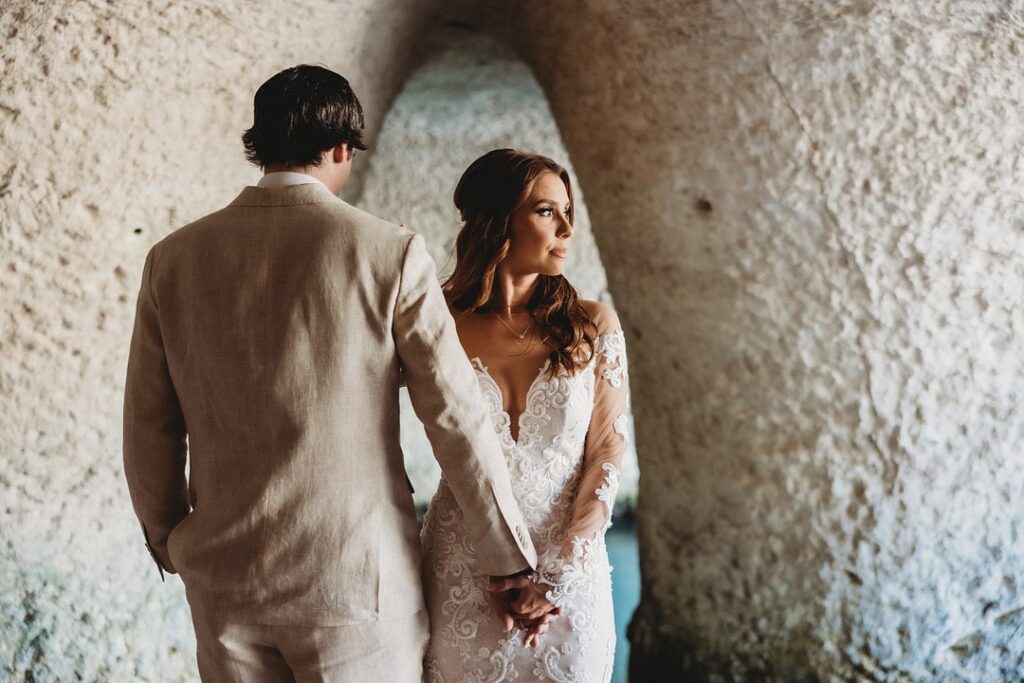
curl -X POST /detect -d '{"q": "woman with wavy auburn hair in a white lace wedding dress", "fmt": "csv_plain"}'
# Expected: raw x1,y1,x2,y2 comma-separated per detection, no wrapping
422,150,629,683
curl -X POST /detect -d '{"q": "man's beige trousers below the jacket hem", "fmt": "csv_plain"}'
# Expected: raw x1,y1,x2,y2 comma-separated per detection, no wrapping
189,603,430,683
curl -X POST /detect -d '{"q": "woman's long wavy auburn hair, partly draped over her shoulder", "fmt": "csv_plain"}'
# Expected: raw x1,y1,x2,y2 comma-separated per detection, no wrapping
443,150,597,376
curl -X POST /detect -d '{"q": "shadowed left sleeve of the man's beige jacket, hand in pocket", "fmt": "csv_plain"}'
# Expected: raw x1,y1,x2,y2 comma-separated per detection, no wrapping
123,247,189,577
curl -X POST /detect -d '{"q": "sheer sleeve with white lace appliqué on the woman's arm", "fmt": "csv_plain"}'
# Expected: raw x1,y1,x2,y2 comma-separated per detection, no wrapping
535,308,629,604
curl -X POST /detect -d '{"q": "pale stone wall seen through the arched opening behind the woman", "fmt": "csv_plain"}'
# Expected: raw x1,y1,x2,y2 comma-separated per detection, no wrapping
356,25,637,509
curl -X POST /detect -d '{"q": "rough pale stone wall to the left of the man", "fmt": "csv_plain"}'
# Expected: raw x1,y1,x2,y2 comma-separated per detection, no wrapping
0,0,423,681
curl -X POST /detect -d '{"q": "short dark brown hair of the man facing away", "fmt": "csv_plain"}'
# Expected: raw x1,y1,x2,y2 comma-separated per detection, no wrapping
242,65,367,168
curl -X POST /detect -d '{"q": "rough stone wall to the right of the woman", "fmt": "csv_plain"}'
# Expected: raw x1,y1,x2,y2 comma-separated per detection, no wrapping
503,0,1024,682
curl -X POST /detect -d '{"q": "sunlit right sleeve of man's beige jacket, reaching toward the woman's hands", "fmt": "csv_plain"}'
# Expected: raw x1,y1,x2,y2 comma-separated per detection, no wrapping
392,236,537,575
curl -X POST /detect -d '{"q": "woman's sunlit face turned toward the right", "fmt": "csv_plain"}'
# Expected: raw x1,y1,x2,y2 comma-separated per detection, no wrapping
502,172,572,275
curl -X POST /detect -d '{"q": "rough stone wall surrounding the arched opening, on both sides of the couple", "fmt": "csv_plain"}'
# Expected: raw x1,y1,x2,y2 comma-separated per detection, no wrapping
0,0,1024,683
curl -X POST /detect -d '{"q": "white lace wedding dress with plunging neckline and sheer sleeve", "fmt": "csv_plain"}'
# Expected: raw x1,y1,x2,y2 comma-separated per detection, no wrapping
422,325,629,683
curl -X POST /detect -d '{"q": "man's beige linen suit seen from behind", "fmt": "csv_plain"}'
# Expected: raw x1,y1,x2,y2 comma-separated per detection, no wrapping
124,183,537,681
